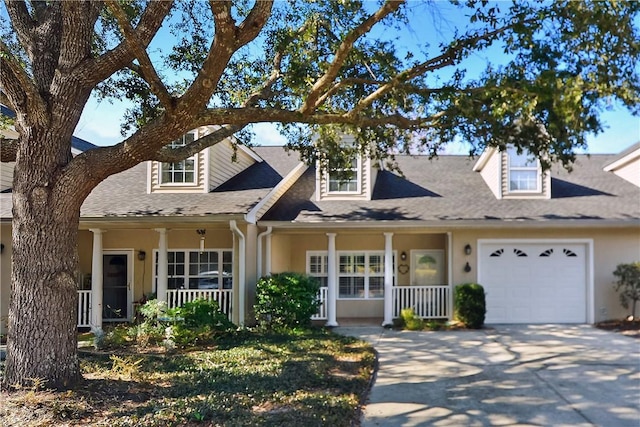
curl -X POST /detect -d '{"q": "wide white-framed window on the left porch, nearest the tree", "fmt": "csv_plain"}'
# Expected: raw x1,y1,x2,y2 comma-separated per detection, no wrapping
154,249,233,289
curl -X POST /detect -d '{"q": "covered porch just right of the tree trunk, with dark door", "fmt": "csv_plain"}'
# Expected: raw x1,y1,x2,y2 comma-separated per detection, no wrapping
78,220,255,328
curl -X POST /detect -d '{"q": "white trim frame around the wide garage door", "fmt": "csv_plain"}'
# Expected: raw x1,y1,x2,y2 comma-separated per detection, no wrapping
476,239,595,323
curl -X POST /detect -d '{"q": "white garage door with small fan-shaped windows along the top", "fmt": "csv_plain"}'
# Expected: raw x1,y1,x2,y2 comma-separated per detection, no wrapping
478,241,587,323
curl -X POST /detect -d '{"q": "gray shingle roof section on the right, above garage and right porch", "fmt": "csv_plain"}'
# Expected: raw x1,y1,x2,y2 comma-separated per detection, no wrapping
262,155,640,227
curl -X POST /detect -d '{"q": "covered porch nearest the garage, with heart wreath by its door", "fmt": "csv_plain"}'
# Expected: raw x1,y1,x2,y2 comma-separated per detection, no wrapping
258,228,466,326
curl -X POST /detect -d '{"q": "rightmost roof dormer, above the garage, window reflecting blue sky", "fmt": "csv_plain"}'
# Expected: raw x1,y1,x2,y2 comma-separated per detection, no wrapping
473,147,551,199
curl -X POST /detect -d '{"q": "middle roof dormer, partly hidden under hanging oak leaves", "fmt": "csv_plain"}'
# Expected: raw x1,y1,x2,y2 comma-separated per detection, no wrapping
316,137,376,201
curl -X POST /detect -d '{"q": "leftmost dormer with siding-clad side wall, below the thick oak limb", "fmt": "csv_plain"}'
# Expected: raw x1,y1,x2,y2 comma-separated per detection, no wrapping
147,126,262,193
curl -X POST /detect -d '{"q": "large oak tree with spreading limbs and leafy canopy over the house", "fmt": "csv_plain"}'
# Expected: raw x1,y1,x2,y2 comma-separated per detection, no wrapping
0,0,640,387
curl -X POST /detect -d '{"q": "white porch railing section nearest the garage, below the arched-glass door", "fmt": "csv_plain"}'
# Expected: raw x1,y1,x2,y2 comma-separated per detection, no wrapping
393,286,450,319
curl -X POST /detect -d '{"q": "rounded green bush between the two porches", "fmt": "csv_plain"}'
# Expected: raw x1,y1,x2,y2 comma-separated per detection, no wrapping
254,273,320,329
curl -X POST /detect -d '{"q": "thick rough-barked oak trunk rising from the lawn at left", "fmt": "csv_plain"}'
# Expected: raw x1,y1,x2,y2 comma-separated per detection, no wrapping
4,129,83,389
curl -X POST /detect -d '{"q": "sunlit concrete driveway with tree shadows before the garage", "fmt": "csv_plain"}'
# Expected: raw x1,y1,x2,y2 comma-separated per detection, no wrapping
336,325,640,427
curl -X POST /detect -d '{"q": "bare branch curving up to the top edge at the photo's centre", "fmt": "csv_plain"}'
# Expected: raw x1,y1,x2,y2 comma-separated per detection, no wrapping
300,0,404,114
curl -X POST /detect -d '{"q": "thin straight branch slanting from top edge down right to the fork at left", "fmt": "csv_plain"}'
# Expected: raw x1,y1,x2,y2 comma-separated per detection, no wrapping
107,0,174,112
